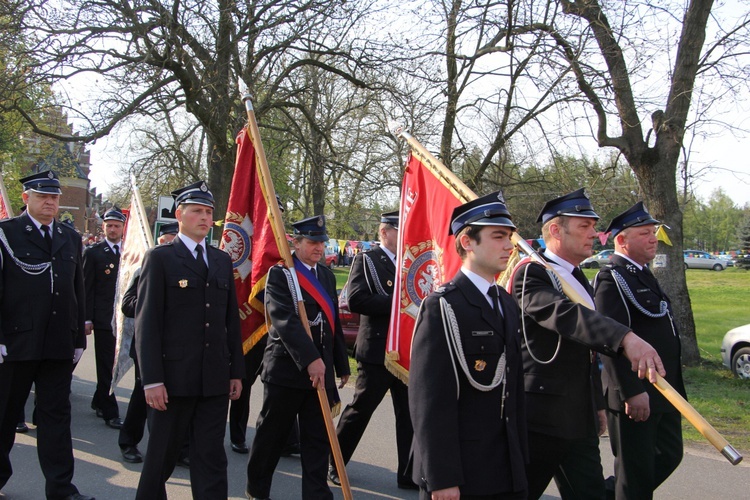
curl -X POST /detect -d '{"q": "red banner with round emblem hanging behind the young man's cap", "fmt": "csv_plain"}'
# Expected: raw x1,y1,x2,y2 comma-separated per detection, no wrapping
386,154,461,382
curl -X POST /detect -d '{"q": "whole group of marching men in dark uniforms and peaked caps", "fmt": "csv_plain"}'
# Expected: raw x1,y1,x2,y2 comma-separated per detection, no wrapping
0,172,685,500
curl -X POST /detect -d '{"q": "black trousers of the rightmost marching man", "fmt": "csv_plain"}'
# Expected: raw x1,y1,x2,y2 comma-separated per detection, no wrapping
607,411,683,500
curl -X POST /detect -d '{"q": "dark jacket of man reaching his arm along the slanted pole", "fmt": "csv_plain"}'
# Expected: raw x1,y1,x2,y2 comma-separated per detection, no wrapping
512,263,630,439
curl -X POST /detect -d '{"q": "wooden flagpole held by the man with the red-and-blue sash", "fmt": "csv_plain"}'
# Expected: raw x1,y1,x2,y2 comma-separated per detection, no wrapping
240,89,352,500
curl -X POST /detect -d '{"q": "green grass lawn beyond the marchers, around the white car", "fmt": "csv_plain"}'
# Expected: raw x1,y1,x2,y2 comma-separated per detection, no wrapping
346,267,750,457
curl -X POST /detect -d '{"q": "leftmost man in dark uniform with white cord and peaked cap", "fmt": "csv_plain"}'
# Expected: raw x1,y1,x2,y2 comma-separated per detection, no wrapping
0,171,92,500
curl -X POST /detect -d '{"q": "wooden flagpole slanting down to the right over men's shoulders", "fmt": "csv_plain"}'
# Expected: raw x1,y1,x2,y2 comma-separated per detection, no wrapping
392,127,742,465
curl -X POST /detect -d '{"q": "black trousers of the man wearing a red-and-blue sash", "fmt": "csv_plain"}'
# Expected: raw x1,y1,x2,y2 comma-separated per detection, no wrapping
247,383,333,500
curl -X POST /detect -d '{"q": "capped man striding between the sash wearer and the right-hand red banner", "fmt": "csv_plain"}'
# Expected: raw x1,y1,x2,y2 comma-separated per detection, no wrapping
328,211,417,489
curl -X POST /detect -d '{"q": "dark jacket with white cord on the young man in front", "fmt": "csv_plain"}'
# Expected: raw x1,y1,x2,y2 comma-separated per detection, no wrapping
409,271,528,495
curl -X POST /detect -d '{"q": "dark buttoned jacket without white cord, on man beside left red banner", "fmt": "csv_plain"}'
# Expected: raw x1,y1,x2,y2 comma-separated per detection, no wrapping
135,238,245,397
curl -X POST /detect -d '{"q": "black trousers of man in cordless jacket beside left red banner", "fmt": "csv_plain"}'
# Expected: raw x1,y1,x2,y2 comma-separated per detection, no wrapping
135,394,229,500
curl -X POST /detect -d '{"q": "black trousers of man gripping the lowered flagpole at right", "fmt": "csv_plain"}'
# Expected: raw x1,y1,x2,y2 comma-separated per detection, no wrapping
526,432,606,500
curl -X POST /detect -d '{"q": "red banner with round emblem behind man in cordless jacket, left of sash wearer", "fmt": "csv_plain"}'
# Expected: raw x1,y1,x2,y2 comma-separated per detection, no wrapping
220,128,281,354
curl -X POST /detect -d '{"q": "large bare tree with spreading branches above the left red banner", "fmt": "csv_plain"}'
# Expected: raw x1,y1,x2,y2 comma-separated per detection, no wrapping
11,0,394,211
